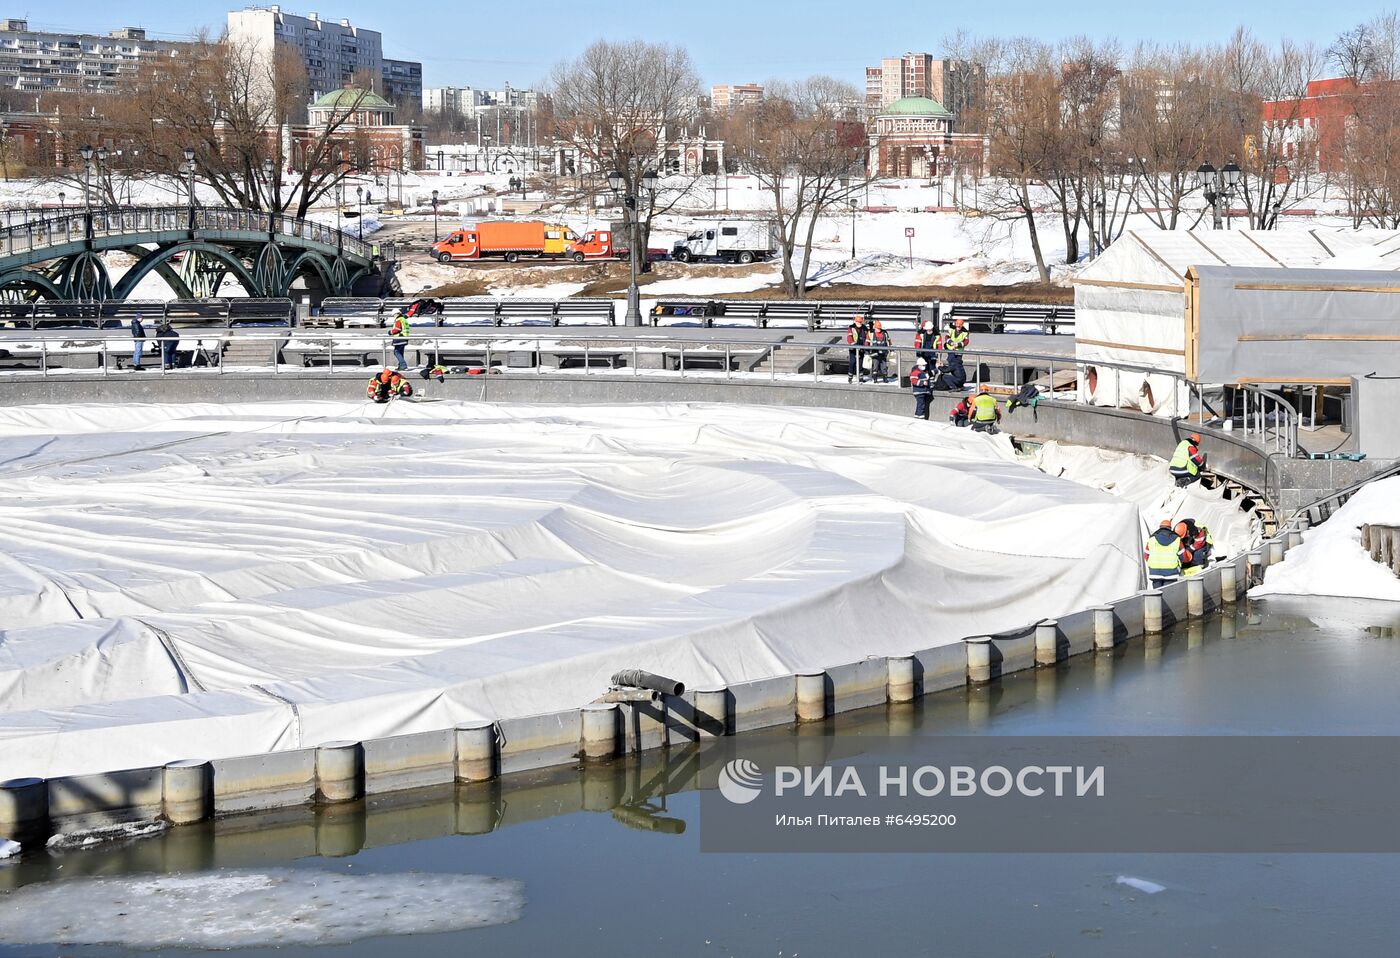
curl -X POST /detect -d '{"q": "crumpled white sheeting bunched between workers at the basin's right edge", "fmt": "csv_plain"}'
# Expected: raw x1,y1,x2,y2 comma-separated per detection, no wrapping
1030,439,1260,559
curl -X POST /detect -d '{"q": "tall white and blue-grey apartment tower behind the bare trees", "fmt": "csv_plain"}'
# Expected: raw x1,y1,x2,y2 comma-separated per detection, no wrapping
228,6,423,101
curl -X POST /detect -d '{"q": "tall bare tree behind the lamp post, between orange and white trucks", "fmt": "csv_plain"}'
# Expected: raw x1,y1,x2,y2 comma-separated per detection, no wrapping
549,41,700,266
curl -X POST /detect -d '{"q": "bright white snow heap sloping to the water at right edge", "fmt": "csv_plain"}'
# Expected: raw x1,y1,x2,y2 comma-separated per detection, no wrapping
1249,476,1400,602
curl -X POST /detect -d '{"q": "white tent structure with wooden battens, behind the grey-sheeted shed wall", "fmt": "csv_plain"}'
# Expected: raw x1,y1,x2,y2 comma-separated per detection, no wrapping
1074,228,1400,416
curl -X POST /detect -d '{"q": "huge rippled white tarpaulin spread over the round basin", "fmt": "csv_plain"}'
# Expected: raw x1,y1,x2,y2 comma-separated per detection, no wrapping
0,402,1142,777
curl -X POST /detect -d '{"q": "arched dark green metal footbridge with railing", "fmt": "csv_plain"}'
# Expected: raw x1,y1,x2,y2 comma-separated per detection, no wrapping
0,206,393,301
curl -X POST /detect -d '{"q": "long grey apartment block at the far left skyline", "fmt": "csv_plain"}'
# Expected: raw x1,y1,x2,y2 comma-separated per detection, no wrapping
0,20,189,92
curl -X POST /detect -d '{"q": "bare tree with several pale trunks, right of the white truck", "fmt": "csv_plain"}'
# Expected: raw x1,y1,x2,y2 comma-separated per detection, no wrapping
725,77,867,298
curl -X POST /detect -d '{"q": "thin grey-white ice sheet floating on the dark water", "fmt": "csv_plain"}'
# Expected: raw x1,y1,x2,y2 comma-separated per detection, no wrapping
0,868,525,950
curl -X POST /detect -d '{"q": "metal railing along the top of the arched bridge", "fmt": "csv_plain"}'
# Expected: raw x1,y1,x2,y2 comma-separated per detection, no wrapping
0,206,372,259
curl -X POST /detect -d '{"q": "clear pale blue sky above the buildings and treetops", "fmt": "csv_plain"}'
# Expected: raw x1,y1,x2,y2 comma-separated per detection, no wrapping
32,0,1394,87
